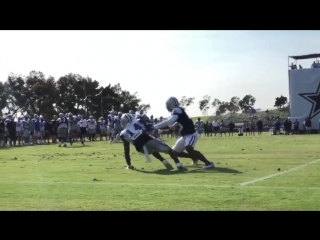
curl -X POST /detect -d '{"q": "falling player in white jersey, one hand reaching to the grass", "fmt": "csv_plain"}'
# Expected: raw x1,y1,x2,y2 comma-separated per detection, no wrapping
120,113,186,170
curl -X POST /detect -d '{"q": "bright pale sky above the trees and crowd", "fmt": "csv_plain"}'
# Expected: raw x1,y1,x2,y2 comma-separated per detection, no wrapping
0,31,320,116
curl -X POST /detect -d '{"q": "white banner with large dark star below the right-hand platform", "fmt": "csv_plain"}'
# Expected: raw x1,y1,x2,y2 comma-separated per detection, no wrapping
289,68,320,130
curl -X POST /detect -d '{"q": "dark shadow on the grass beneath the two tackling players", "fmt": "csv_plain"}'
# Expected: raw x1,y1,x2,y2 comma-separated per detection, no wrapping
135,167,242,175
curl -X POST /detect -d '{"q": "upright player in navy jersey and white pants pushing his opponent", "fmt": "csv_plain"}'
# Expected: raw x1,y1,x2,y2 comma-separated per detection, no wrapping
153,97,214,169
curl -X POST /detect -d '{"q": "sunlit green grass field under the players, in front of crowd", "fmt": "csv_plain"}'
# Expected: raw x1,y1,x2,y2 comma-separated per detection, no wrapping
0,133,320,210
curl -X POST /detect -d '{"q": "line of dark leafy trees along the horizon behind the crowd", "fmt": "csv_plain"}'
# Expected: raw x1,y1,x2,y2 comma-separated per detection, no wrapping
0,71,289,118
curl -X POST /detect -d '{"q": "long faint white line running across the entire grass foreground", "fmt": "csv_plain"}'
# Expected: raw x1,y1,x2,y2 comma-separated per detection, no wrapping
0,181,320,191
